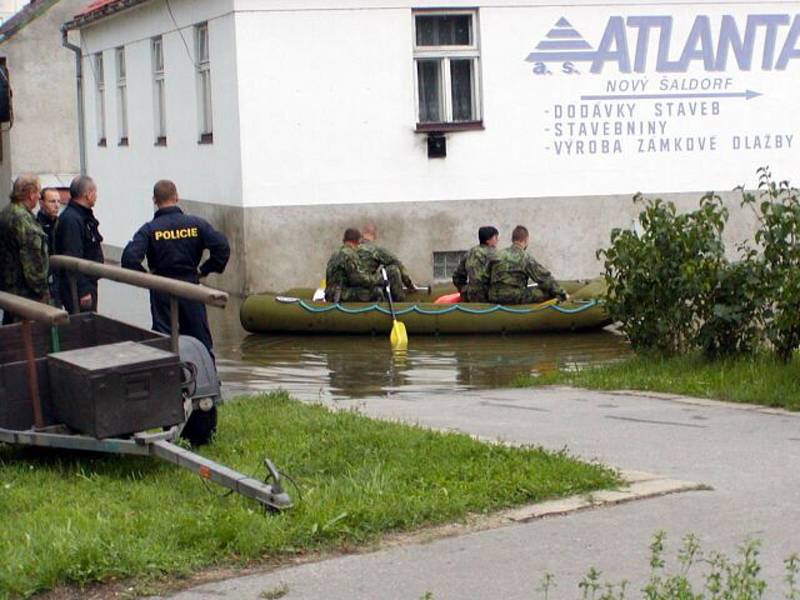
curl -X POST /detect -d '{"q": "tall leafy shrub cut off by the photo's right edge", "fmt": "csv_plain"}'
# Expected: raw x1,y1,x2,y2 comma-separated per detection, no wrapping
740,167,800,362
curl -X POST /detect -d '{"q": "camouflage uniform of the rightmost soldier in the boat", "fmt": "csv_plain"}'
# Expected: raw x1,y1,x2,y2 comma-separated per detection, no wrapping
489,244,564,304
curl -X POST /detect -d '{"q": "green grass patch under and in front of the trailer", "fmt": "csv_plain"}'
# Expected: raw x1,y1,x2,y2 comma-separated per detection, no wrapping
0,393,618,596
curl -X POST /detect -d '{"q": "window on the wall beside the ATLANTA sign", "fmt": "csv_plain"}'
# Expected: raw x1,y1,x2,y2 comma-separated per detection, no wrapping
414,11,481,130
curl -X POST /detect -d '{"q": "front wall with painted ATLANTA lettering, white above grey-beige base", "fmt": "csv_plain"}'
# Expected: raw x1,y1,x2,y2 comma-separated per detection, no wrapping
236,0,800,290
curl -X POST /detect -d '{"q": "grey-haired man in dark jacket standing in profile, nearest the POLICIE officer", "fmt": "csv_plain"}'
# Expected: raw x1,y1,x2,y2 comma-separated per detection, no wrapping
54,175,103,313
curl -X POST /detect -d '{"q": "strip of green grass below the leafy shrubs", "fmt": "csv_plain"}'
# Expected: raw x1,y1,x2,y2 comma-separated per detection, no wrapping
515,354,800,410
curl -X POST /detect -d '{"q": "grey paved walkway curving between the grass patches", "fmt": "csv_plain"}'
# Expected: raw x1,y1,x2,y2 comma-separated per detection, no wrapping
162,388,800,600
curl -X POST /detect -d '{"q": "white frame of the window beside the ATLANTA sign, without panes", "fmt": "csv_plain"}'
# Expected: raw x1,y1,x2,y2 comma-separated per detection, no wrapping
411,8,483,133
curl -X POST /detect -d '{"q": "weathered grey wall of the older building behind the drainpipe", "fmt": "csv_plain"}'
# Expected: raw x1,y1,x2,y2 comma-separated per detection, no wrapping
0,0,84,196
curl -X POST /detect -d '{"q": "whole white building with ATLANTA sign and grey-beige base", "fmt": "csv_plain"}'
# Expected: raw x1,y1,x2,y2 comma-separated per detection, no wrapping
68,0,800,291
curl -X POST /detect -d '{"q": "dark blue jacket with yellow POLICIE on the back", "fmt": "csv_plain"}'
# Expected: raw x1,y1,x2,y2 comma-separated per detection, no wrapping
121,206,231,283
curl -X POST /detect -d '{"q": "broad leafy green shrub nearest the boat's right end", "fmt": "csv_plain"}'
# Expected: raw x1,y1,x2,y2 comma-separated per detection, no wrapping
597,194,728,354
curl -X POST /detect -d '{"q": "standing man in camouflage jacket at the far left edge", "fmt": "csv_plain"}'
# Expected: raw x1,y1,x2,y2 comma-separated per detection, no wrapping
0,175,50,325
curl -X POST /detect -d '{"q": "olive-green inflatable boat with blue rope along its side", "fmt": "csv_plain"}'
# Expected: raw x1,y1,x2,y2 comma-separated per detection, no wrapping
240,278,611,335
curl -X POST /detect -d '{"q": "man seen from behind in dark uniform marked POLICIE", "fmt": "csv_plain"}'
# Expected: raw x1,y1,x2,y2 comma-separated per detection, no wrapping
121,179,231,352
